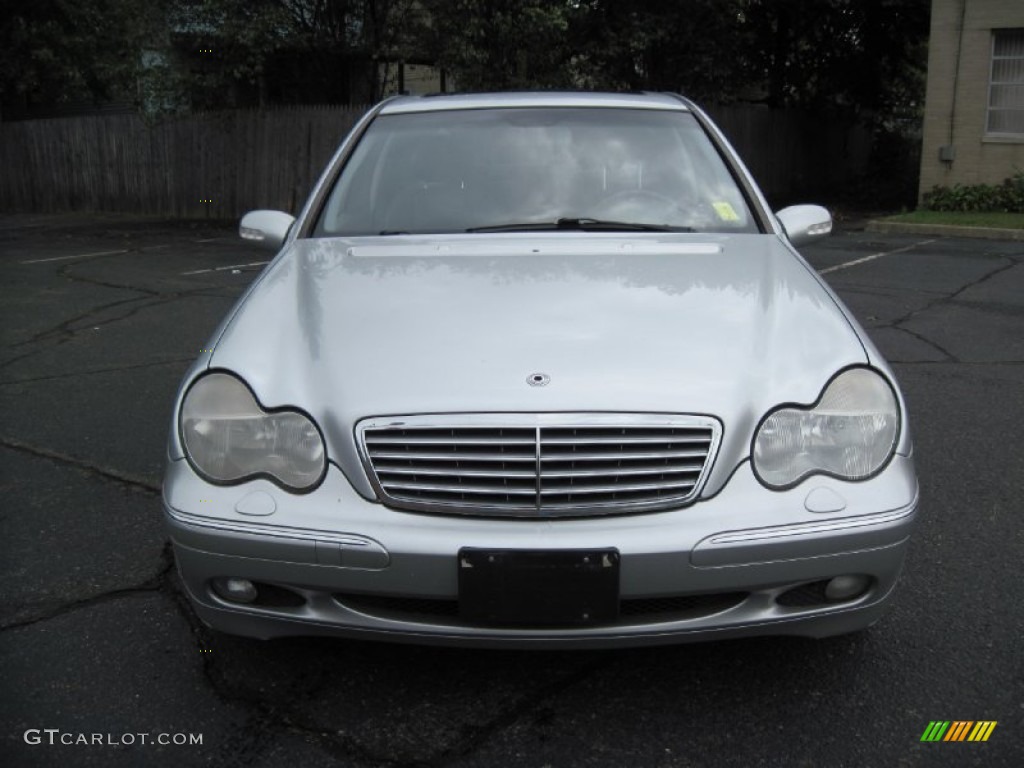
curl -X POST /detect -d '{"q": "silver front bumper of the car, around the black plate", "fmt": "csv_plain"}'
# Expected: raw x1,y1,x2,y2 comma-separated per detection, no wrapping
164,456,918,647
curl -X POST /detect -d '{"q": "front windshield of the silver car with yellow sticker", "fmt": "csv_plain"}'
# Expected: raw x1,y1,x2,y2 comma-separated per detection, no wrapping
314,108,758,237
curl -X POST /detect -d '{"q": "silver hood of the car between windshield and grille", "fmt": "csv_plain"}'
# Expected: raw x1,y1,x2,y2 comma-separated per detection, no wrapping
210,232,867,495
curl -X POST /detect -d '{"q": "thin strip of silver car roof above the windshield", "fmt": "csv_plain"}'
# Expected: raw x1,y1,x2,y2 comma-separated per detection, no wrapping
380,91,689,115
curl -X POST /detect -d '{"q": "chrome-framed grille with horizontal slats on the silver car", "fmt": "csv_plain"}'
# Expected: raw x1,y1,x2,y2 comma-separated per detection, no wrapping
357,414,721,517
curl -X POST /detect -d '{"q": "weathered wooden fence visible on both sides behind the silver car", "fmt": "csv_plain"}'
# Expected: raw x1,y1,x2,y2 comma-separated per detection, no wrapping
0,105,869,218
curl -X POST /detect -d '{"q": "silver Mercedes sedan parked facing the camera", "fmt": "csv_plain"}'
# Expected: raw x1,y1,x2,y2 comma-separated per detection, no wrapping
164,92,918,647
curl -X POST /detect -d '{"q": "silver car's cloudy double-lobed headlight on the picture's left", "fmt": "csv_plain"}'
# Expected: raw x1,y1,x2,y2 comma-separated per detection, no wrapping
180,373,326,490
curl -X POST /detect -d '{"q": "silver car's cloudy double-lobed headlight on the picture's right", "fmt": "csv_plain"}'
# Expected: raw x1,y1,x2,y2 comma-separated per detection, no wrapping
754,368,899,487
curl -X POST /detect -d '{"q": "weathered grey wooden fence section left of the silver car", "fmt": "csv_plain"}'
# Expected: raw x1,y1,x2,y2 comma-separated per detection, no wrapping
0,108,365,218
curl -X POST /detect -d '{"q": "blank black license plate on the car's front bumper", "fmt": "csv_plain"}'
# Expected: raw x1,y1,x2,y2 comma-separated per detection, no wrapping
459,548,618,627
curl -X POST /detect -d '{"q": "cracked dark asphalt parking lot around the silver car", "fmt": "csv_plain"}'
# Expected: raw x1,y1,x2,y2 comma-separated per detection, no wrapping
0,211,1024,768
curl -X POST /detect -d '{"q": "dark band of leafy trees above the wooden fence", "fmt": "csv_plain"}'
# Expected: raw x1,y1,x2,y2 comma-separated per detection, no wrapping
0,0,929,124
